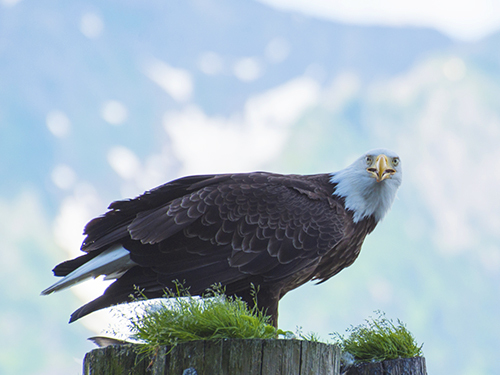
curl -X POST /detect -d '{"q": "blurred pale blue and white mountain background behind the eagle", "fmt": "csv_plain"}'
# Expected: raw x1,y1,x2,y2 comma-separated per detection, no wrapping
0,0,500,375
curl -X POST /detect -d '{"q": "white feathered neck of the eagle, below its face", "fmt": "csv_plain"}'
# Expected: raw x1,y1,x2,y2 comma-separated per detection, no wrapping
330,168,399,223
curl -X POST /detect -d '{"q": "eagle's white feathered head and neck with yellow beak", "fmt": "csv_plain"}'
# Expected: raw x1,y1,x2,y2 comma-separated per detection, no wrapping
330,149,403,223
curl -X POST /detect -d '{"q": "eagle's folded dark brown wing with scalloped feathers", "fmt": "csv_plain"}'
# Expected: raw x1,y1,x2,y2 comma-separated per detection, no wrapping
127,173,346,283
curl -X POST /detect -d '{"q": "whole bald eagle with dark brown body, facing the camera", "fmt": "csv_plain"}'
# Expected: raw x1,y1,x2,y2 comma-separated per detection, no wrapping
42,149,402,326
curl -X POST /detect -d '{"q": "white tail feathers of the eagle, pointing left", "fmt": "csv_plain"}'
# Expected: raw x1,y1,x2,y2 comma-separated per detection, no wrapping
42,247,135,294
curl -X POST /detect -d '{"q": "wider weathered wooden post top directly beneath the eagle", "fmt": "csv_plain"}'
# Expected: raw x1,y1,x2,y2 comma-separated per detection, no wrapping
83,339,340,375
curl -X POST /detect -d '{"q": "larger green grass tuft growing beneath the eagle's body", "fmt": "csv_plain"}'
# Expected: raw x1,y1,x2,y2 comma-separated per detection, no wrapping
125,287,278,351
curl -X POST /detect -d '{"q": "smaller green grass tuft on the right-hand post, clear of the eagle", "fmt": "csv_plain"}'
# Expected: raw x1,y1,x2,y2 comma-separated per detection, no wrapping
333,311,422,362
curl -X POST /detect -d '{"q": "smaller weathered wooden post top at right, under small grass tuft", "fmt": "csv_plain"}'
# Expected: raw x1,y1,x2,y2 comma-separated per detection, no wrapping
346,357,427,375
